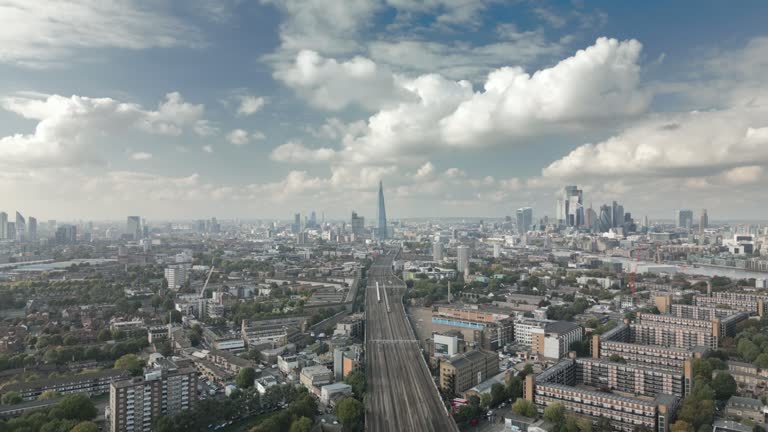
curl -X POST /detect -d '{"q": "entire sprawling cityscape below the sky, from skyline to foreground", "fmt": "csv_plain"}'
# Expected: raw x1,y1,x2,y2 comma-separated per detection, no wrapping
0,184,768,432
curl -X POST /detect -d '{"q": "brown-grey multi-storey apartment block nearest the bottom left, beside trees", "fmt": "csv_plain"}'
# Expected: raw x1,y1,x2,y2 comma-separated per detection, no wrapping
108,358,197,432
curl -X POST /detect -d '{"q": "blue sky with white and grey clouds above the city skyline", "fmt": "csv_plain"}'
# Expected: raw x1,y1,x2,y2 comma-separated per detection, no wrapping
0,0,768,221
